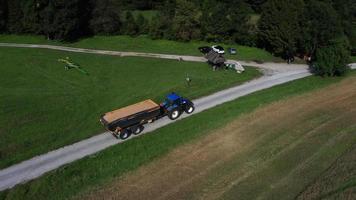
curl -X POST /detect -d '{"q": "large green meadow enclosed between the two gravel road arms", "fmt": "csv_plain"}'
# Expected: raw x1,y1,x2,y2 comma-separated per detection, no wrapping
0,48,261,168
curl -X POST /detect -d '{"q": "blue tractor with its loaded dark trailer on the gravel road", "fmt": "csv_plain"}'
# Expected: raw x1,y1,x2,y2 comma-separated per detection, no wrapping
100,93,195,140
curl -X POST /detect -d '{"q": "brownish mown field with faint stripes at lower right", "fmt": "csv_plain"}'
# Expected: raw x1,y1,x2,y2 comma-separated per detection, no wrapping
80,77,356,200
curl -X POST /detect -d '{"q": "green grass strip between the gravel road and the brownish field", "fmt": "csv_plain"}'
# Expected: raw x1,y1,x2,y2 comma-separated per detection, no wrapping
0,73,356,199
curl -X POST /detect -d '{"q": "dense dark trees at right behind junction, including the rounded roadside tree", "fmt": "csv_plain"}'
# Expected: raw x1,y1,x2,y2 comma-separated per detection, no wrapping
258,0,356,76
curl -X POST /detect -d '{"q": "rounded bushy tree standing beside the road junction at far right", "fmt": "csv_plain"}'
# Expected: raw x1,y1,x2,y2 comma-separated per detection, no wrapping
312,37,350,76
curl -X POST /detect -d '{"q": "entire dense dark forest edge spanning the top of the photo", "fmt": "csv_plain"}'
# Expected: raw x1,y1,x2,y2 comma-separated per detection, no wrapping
0,0,356,75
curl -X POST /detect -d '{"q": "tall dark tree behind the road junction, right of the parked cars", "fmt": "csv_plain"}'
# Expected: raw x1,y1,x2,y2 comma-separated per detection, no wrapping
258,0,304,55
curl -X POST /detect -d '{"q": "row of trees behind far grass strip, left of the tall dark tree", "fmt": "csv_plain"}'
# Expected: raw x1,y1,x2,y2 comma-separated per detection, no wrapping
0,0,263,42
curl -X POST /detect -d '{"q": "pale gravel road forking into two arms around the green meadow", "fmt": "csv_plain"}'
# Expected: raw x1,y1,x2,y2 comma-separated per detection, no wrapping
0,43,311,191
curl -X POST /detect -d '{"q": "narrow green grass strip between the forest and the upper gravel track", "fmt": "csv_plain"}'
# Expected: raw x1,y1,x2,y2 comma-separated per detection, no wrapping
0,35,284,62
